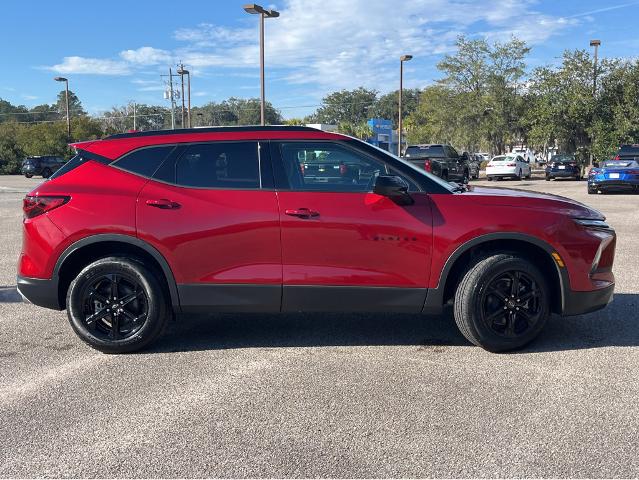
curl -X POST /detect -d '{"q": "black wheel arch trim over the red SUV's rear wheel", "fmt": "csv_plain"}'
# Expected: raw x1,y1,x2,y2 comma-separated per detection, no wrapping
53,234,180,310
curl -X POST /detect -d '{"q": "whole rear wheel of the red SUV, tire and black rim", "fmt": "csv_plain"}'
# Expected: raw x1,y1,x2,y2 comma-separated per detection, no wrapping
67,257,171,353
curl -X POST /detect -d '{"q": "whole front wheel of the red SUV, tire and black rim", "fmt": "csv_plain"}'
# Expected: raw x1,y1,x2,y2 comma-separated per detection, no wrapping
454,254,550,352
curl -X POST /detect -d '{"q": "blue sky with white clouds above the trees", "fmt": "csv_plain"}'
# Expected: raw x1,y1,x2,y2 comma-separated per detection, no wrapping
0,0,639,118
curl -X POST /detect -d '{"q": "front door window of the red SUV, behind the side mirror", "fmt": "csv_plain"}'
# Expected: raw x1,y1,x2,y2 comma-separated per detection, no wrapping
280,142,416,192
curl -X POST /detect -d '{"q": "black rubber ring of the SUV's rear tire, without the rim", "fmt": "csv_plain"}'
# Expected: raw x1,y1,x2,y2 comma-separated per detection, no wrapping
67,257,168,353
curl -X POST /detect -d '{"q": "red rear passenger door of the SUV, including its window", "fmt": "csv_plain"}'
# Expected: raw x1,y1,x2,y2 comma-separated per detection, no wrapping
137,141,282,311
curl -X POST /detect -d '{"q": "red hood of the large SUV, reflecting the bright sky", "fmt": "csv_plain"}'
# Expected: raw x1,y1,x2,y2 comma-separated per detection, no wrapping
463,186,606,220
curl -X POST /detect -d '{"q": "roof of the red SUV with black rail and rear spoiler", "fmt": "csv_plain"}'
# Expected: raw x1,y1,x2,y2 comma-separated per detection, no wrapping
71,125,344,159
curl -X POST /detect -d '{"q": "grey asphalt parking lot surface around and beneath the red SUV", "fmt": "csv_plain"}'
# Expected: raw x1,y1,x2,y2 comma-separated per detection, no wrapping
0,176,639,477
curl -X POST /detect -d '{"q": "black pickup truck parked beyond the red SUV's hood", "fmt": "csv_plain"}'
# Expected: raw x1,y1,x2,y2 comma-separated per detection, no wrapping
404,145,472,183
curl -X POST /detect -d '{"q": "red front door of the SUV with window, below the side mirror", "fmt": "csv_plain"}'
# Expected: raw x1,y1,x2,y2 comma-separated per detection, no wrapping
271,141,432,312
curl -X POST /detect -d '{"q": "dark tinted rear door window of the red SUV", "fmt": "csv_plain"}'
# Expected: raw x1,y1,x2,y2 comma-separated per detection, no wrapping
175,142,260,189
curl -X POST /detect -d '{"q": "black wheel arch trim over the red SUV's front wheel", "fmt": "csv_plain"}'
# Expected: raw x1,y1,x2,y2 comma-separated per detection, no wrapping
424,232,570,314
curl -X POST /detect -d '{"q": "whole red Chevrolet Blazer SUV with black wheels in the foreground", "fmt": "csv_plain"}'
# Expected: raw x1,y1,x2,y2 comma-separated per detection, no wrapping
18,126,615,352
